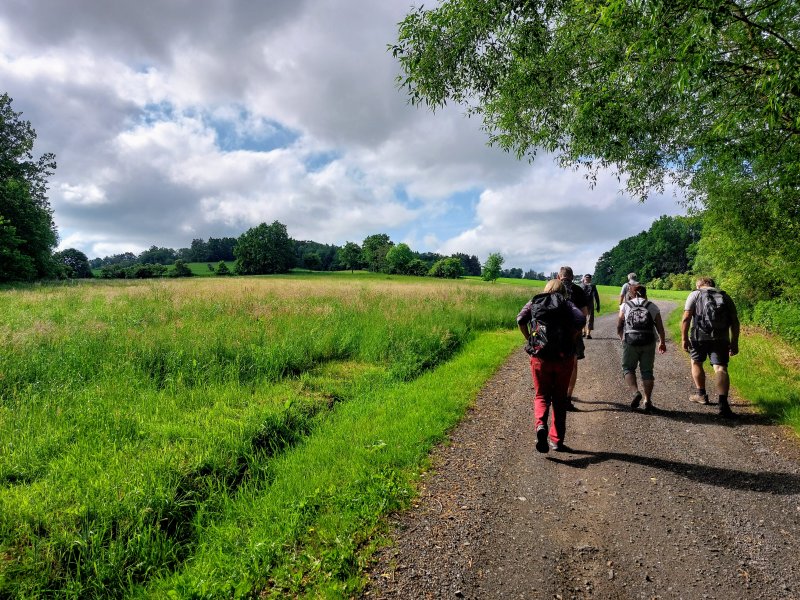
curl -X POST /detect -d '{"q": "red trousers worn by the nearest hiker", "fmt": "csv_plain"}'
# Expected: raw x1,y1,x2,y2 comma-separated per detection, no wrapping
531,356,573,443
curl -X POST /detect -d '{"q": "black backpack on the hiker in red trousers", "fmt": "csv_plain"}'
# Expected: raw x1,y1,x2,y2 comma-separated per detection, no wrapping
525,294,575,360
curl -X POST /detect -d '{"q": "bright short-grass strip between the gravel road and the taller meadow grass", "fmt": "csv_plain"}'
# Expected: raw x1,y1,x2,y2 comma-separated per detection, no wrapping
149,332,519,598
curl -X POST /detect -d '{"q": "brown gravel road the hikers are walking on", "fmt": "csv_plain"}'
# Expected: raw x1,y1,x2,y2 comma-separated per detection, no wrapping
365,302,800,599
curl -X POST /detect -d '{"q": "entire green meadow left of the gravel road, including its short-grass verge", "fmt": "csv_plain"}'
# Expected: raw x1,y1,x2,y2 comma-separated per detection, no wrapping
0,273,532,598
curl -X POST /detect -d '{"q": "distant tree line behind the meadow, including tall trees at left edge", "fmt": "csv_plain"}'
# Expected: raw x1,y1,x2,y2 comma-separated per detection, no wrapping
0,94,536,281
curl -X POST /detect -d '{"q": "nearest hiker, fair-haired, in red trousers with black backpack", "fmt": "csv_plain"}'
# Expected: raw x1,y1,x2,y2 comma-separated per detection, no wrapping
517,279,586,452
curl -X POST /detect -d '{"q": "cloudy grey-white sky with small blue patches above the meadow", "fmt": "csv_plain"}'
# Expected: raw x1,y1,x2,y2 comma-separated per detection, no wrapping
0,0,683,273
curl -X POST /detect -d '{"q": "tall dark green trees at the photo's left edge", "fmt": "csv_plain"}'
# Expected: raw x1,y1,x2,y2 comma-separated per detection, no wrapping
0,94,58,281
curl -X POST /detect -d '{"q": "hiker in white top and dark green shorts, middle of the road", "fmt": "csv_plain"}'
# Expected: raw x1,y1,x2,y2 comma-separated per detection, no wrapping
617,279,667,413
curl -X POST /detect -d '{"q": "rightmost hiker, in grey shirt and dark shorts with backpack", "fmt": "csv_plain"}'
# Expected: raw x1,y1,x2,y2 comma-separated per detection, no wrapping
681,277,739,419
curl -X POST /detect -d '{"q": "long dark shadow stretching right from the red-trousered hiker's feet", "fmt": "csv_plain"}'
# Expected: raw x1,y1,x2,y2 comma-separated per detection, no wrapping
547,450,800,495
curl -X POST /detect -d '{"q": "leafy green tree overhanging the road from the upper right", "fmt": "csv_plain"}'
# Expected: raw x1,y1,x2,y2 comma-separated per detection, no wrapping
392,0,800,304
